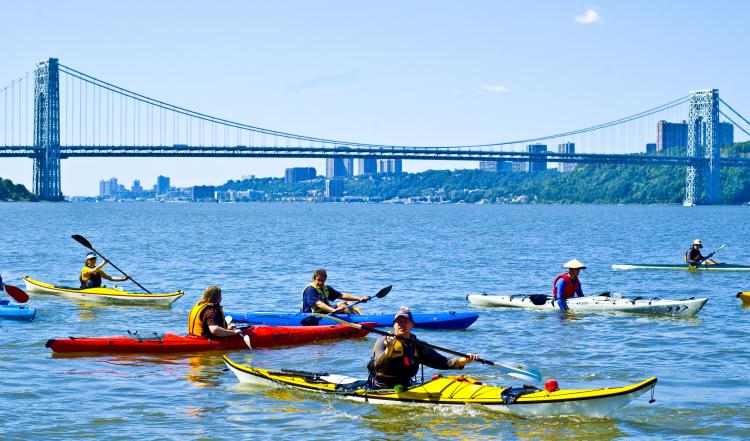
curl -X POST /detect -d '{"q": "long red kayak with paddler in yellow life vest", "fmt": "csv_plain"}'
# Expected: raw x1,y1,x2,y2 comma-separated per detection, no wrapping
45,323,375,354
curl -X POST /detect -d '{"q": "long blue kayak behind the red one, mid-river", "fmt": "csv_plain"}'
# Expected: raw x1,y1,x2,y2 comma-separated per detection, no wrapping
226,311,479,329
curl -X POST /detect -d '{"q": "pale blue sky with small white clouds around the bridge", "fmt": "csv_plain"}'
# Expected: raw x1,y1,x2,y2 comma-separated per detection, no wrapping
0,0,750,196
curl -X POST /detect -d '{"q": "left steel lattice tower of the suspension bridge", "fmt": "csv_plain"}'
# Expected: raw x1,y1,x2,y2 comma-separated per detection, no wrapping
34,58,62,201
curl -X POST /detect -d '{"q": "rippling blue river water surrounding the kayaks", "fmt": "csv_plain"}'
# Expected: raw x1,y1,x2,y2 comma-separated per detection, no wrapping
0,203,750,440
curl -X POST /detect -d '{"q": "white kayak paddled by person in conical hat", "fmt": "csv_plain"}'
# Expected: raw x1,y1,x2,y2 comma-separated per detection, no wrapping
466,293,708,317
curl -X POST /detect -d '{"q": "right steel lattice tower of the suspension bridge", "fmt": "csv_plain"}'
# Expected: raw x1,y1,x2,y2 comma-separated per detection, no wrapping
683,89,721,205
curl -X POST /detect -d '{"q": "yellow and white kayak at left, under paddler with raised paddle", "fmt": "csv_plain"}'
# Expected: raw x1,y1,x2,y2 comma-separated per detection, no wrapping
23,276,185,306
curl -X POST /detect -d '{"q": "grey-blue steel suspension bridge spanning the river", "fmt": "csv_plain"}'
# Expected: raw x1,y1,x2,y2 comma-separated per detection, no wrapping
0,58,750,205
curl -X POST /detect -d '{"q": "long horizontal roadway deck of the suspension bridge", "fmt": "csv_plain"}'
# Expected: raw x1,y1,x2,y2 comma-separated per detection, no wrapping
0,144,750,167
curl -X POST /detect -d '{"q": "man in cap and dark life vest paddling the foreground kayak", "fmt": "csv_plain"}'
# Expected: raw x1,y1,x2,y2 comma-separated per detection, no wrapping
367,306,479,390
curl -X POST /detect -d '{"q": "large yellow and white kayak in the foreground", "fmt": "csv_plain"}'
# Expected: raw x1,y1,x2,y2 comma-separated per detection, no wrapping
224,355,656,417
